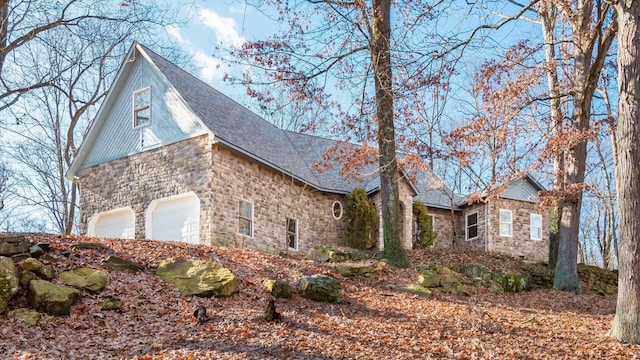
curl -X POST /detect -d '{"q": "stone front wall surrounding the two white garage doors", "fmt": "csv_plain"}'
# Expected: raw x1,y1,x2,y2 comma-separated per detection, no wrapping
80,135,212,242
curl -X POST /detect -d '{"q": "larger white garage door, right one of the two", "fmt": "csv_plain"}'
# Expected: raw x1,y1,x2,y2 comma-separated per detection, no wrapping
147,192,200,244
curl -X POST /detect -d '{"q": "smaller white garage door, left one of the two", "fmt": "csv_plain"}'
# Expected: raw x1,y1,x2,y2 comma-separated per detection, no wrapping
87,207,136,239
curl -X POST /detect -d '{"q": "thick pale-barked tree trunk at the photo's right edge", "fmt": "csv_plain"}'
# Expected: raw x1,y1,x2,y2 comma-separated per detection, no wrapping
611,1,640,344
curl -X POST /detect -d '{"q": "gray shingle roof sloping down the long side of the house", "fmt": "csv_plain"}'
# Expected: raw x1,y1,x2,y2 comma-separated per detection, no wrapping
139,45,451,208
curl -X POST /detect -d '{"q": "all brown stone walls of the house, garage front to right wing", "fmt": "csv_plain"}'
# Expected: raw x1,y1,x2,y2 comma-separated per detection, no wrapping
81,135,549,260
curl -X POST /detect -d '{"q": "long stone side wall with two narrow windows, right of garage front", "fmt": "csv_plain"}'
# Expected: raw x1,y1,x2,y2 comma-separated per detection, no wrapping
206,145,345,252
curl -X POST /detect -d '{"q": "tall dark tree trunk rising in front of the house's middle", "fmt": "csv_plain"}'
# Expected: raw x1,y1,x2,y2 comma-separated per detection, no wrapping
370,0,409,267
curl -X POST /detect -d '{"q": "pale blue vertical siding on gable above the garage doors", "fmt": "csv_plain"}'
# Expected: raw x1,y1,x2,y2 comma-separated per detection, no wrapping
82,55,208,168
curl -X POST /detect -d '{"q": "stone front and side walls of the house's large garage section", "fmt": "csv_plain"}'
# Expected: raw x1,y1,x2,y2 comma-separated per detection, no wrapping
81,135,345,252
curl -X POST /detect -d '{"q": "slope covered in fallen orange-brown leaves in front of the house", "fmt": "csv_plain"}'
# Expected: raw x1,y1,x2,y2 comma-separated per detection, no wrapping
0,236,640,359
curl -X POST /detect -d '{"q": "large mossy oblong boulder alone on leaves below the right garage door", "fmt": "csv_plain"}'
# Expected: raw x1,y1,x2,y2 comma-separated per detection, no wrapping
156,259,239,297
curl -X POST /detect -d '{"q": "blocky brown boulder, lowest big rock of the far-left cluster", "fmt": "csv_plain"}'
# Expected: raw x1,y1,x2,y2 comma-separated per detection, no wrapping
28,280,81,315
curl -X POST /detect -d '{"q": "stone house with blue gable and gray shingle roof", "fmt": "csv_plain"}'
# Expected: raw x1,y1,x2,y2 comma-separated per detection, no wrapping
68,44,548,259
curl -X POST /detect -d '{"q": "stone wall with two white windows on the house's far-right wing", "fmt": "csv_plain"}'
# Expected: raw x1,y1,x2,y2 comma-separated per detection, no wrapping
488,198,549,261
